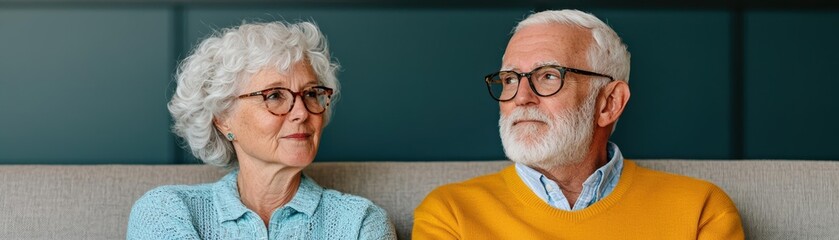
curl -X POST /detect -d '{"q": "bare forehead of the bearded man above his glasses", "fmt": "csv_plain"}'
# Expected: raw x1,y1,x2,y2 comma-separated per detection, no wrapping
502,23,594,71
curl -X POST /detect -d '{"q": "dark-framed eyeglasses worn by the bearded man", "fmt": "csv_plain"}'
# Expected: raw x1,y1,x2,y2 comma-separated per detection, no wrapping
484,65,615,102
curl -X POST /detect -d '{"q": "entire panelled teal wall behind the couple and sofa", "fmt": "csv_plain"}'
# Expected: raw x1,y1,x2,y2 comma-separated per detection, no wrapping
0,4,839,164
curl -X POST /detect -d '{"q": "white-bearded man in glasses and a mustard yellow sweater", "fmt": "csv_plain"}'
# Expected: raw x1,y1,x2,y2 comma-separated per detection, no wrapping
413,10,744,239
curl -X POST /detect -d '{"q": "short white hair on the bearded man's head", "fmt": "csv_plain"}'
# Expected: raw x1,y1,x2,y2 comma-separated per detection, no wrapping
513,9,629,82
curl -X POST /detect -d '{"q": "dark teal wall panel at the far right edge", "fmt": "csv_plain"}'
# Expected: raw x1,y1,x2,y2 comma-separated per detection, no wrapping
744,11,839,159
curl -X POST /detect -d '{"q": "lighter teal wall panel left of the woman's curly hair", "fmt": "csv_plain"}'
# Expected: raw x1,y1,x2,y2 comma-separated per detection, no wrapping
0,7,176,163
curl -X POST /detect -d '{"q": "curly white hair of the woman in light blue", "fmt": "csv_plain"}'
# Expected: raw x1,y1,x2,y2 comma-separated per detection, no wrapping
169,22,341,166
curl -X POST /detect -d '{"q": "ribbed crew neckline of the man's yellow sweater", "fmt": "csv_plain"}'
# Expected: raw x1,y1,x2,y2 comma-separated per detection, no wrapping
501,159,637,222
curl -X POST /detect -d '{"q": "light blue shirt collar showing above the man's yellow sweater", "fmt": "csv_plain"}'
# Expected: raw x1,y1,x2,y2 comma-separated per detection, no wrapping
516,142,623,211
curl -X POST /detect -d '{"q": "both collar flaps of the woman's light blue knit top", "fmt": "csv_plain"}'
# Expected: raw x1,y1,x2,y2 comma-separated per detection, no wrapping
213,169,323,222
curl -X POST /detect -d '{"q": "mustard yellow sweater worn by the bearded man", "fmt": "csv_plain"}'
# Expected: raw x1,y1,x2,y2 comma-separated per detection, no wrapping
413,160,744,240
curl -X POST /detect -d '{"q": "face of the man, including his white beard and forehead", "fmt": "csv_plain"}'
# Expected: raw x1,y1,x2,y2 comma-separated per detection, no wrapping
499,24,596,168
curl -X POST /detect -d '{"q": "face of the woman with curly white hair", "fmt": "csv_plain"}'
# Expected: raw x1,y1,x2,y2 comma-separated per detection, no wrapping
218,60,323,168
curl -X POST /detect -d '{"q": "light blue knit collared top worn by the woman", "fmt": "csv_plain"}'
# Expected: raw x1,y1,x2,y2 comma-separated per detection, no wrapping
127,171,396,240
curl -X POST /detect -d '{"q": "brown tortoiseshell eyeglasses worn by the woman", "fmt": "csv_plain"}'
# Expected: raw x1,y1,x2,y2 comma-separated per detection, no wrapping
239,86,333,115
